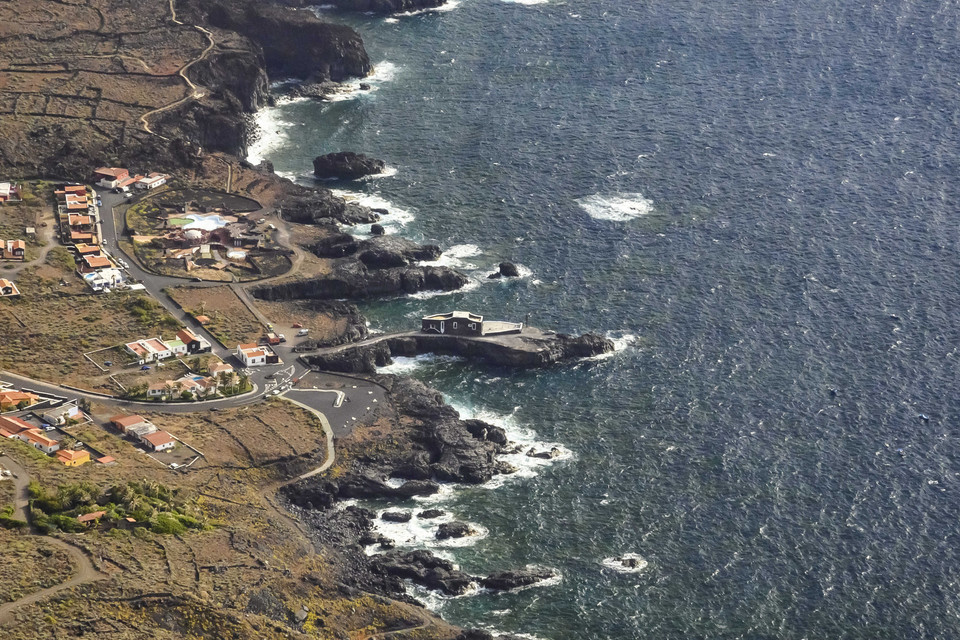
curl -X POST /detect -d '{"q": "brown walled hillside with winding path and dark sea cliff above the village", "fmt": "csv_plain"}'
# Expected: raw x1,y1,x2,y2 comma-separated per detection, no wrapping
0,0,369,178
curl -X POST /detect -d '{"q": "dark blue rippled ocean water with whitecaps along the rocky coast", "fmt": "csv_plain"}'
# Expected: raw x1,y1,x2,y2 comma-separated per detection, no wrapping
253,0,960,640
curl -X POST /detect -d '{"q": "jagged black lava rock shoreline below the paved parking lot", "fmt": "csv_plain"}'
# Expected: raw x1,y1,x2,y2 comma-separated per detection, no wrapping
284,376,559,608
